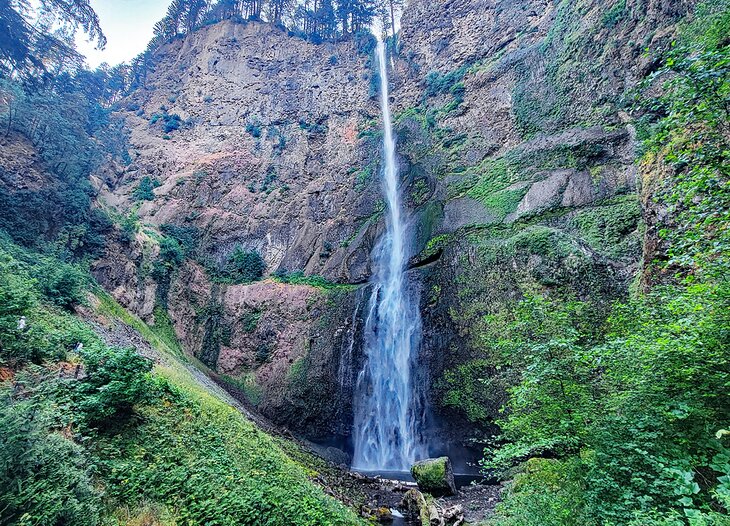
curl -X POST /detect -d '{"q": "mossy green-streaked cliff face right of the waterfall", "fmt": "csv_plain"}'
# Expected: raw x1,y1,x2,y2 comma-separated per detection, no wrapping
386,0,691,450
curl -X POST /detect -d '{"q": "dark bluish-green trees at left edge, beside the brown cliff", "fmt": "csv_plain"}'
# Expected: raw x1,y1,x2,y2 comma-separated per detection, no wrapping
0,78,122,260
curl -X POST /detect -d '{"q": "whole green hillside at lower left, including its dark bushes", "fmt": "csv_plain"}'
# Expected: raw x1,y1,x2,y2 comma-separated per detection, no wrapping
0,237,358,526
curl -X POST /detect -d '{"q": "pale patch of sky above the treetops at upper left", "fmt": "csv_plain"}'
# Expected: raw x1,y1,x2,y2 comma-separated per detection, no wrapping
76,0,171,69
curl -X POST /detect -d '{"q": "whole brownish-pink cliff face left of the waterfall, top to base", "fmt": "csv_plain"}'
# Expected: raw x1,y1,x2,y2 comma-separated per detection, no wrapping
94,22,382,444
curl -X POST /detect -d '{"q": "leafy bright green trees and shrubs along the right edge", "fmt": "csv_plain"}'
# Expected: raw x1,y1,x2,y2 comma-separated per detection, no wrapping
483,1,730,526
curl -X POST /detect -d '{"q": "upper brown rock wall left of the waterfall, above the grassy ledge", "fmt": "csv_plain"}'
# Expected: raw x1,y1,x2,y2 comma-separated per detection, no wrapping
99,22,379,282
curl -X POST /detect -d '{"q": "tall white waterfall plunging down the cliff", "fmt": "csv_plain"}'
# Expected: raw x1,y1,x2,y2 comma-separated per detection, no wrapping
353,39,425,471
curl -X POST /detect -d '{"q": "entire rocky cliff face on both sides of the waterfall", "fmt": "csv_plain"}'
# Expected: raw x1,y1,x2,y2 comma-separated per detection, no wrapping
95,0,690,458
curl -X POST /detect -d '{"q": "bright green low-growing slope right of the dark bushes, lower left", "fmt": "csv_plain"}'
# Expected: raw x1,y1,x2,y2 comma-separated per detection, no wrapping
92,293,358,525
